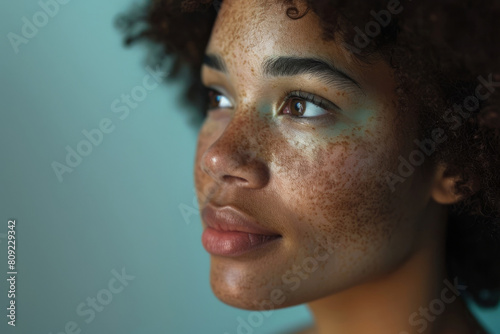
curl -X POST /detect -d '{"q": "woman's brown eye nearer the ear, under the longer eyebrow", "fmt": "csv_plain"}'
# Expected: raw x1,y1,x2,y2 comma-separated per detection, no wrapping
281,91,340,118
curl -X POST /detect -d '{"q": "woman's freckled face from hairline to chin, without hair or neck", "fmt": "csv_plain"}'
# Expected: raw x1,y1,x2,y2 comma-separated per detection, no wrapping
195,0,440,309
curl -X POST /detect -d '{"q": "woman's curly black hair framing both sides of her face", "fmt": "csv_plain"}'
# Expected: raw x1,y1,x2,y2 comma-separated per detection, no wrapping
117,0,500,307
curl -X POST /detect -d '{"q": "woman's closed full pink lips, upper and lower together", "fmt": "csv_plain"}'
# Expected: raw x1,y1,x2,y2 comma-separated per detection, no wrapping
201,204,281,256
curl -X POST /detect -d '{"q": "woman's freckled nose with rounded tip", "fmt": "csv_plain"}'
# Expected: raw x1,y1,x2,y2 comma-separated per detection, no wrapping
200,115,270,189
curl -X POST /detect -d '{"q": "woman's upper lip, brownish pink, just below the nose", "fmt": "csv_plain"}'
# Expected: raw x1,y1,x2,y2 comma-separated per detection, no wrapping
201,204,279,235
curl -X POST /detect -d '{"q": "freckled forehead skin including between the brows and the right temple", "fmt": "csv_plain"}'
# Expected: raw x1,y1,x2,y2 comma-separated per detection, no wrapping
202,0,397,103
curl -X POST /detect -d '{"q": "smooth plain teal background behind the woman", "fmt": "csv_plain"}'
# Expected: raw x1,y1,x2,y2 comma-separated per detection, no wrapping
0,0,500,334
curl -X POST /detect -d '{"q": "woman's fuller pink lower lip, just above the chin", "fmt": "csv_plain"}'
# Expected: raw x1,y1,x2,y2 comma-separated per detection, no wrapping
201,227,281,256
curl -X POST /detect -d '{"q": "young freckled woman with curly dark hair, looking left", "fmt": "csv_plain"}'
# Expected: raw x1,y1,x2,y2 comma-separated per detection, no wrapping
122,0,500,334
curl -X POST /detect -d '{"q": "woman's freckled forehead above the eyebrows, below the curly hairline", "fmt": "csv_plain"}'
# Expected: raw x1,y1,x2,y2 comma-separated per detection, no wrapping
206,0,348,73
